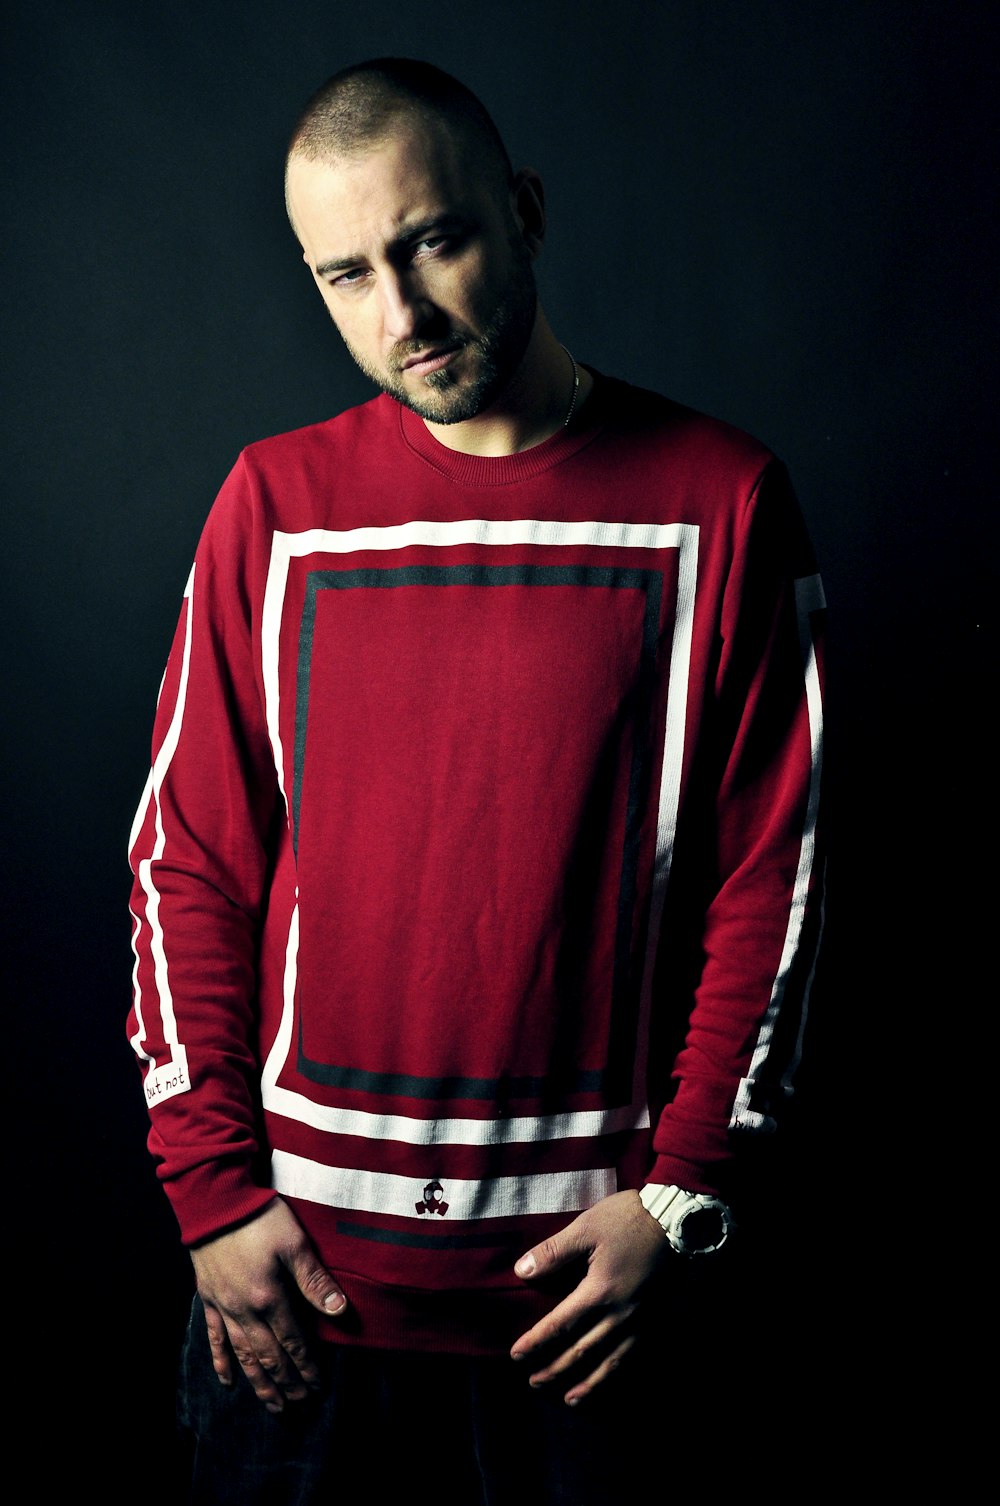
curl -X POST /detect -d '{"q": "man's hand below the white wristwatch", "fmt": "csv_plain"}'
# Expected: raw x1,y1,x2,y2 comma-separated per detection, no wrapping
511,1191,670,1407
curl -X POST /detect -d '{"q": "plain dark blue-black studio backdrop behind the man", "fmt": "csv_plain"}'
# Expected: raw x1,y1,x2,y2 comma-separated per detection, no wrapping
2,0,998,1500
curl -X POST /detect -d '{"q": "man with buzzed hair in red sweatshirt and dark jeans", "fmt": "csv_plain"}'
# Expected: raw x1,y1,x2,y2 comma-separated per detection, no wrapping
131,59,822,1506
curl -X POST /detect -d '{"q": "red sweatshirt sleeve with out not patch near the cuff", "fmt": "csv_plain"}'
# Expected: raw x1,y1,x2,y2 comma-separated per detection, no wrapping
130,467,279,1242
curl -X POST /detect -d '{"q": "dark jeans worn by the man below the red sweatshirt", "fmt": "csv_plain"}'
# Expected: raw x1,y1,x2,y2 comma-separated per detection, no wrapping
179,1300,663,1506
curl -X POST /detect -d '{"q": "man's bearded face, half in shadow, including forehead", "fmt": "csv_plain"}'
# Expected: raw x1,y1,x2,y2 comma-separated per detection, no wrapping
288,120,536,423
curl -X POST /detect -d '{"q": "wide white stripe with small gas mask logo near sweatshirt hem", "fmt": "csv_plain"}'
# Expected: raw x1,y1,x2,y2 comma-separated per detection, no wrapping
271,1151,617,1223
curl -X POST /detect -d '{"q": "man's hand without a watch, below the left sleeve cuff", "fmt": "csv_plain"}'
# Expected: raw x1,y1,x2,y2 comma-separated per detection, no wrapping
191,1197,348,1413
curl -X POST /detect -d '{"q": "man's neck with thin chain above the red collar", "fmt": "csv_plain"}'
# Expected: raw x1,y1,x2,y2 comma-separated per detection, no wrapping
425,307,593,455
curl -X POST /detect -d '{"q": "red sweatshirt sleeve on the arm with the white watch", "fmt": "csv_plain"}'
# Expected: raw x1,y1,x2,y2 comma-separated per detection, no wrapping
649,464,824,1191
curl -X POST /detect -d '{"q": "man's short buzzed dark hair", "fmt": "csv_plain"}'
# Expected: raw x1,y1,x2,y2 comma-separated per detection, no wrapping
288,57,514,190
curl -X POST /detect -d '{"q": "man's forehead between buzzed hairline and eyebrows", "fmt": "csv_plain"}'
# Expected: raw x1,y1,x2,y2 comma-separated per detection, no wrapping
288,120,497,265
